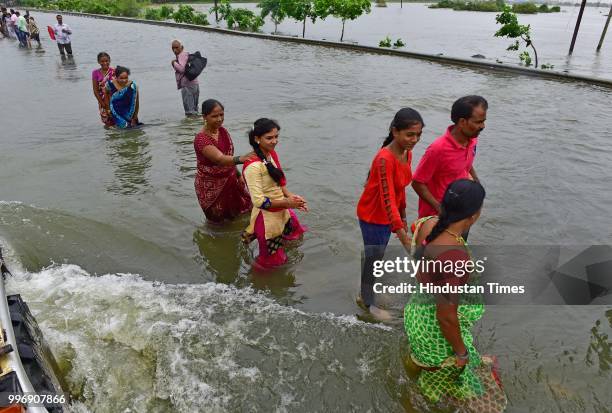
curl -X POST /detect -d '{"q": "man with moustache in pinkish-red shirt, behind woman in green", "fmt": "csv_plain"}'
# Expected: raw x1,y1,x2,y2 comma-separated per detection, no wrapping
412,95,489,218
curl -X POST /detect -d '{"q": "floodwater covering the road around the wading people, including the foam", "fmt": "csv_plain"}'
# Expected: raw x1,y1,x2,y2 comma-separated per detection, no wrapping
0,14,612,412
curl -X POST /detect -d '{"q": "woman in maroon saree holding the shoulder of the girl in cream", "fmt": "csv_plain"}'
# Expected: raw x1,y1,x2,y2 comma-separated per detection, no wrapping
193,99,253,223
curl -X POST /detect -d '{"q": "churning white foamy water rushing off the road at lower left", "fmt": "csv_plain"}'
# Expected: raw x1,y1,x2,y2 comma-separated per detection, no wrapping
7,265,396,412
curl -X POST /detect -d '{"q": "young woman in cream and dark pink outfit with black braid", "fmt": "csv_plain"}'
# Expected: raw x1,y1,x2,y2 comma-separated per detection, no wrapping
243,118,308,268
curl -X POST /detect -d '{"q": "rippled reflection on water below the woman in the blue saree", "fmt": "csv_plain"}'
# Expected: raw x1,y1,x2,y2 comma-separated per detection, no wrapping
106,129,153,195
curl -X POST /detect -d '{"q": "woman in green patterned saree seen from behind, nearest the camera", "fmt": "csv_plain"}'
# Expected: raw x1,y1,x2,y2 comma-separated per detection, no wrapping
404,179,507,412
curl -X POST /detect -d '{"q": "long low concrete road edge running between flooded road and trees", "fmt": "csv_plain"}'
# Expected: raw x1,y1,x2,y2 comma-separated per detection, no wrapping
32,9,612,89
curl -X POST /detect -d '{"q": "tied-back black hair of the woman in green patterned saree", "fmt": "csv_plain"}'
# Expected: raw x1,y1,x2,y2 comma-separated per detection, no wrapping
425,179,485,243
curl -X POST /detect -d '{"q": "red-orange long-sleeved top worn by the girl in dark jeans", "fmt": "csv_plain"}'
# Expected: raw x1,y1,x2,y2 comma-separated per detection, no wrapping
357,147,412,232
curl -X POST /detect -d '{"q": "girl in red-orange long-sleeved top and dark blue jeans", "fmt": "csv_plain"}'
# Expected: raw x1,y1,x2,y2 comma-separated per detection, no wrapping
357,108,425,319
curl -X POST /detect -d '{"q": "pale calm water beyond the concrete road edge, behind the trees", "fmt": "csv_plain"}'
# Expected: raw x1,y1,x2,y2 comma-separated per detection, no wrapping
193,3,612,79
